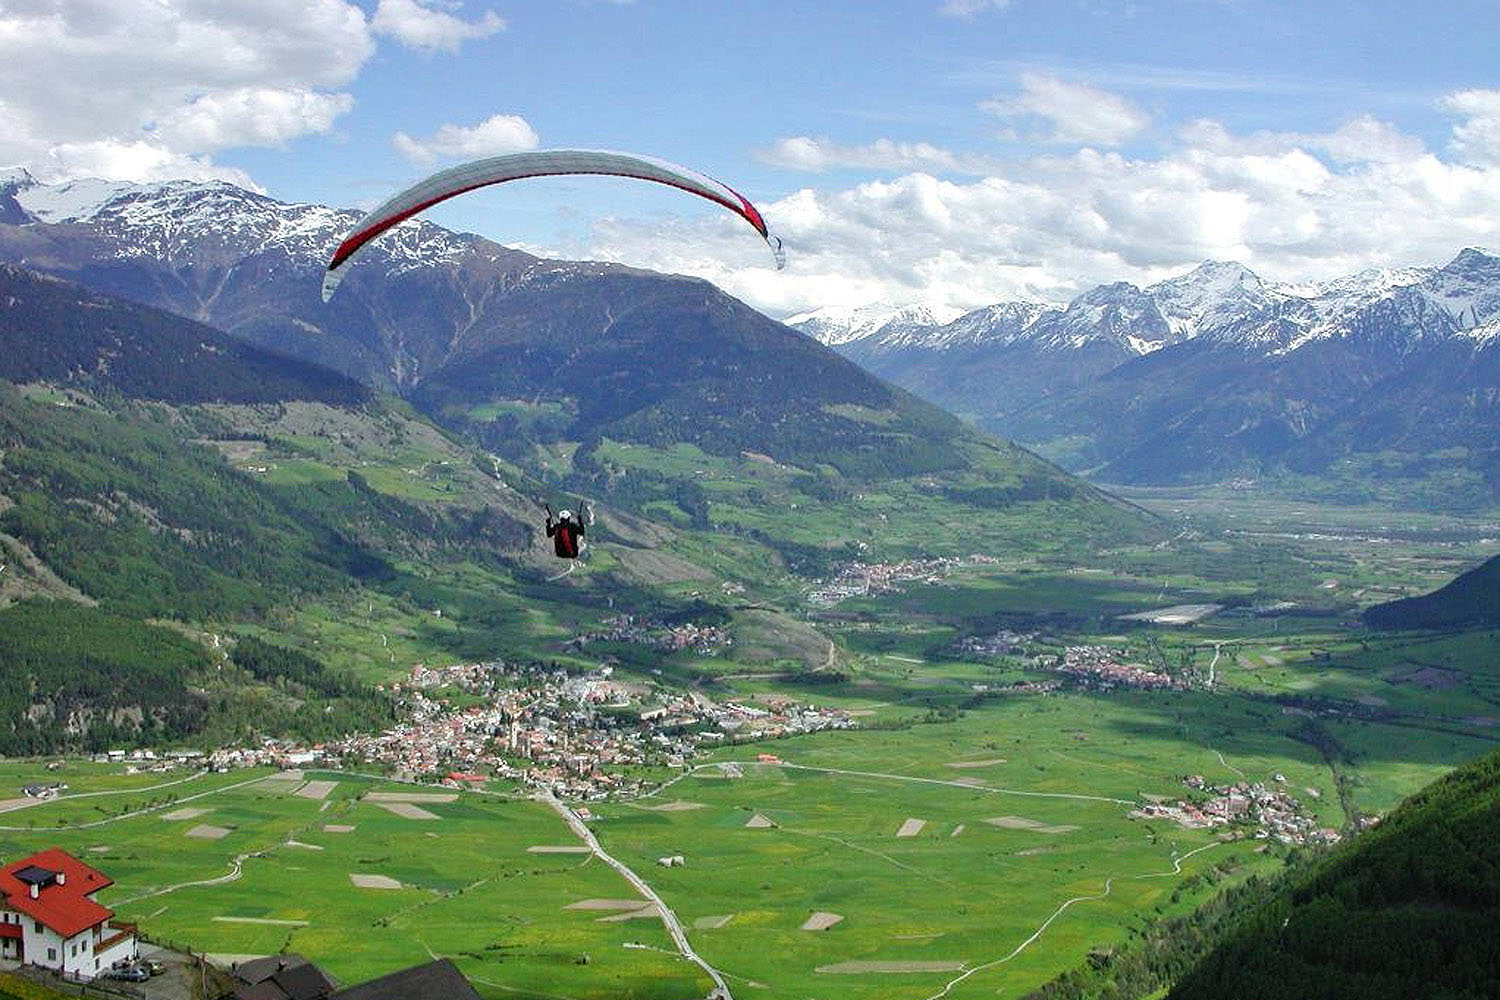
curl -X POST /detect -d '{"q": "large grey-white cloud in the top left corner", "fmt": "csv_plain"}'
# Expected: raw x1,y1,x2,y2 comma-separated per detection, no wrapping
0,0,374,180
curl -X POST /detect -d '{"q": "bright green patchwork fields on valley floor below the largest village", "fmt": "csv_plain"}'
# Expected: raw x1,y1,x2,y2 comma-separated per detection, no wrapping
0,665,1467,1000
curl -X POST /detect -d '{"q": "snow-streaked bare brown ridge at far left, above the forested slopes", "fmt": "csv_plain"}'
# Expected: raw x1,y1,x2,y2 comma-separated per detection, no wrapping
0,171,600,393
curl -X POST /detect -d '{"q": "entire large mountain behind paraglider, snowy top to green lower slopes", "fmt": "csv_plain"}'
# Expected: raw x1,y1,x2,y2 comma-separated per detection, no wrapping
0,184,1157,568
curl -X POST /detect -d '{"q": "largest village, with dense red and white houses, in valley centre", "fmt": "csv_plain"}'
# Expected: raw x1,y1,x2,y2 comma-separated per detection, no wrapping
207,661,855,801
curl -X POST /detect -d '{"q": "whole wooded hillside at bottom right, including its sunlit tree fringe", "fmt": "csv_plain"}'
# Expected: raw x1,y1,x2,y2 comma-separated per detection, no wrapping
1026,751,1500,1000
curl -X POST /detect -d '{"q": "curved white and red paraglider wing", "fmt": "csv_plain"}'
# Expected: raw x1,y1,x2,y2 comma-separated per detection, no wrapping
323,150,786,301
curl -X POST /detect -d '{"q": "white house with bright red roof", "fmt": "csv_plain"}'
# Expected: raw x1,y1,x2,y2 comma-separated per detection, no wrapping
0,847,137,979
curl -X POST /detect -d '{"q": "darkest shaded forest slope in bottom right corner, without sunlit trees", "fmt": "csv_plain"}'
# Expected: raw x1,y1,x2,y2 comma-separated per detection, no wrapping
1169,753,1500,1000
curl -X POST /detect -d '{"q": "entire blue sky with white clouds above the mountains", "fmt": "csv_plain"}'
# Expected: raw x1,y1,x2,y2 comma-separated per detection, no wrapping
0,0,1500,315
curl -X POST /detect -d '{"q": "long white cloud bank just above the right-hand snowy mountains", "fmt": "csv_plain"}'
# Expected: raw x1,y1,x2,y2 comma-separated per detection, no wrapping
570,94,1500,316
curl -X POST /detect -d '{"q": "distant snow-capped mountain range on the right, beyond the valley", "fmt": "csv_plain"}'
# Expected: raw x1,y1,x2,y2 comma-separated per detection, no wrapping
786,249,1500,499
